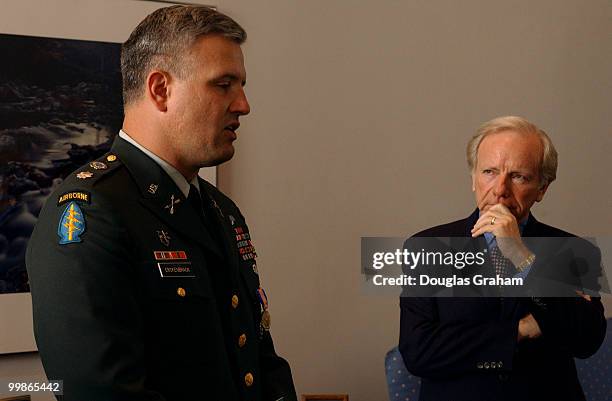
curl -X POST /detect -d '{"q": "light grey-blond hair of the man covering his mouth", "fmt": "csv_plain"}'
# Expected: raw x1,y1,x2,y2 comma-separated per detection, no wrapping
466,116,558,186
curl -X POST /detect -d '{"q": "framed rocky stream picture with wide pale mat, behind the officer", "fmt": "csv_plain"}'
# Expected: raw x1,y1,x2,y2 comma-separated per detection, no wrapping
0,0,216,354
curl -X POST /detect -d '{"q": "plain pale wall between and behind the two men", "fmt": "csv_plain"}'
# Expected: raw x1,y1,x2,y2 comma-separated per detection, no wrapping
219,0,612,401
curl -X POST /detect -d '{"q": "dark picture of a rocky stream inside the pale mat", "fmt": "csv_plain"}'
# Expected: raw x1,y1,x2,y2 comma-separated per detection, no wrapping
0,34,123,352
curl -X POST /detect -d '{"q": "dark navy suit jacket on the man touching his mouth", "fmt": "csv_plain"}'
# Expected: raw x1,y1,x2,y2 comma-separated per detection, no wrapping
399,210,606,401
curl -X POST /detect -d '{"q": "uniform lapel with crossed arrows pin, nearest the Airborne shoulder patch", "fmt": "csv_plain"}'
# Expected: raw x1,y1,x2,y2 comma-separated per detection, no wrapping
111,137,222,256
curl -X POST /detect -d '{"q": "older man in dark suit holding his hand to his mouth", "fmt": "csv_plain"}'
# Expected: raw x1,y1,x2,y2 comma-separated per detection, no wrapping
399,117,606,401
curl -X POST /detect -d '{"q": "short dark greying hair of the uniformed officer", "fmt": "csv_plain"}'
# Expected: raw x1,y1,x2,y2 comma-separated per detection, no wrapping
121,6,246,107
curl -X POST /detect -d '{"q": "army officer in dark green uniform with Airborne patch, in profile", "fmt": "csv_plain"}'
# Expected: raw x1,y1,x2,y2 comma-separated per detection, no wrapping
27,6,296,401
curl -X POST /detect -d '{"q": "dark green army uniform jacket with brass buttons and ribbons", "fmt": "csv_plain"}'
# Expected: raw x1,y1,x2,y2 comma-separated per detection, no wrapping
27,138,296,401
